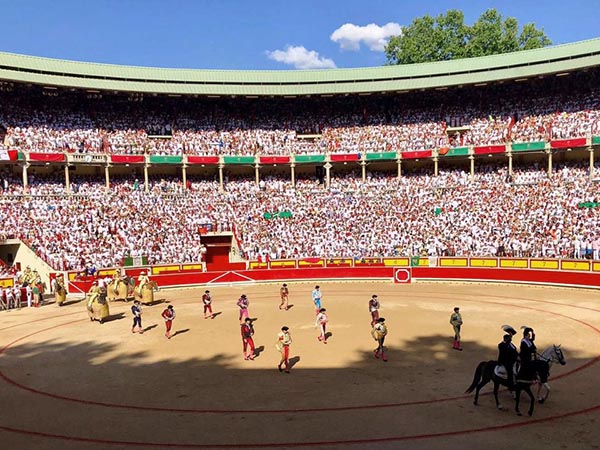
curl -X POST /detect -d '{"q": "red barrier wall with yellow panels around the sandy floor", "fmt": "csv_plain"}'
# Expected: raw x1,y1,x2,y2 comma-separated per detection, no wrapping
56,257,600,293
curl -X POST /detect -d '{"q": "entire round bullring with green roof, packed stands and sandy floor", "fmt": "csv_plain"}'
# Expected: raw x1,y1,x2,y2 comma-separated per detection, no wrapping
0,39,600,450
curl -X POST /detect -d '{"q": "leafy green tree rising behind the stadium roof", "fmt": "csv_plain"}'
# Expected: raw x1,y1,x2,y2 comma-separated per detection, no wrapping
385,9,551,64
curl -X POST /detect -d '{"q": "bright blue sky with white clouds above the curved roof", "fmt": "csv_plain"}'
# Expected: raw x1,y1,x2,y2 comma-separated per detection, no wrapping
0,0,600,70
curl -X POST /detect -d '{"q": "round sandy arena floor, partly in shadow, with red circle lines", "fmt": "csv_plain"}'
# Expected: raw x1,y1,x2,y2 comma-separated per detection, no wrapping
0,282,600,450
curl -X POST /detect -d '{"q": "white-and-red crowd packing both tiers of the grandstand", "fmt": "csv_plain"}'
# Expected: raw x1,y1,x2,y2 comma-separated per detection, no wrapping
0,42,600,270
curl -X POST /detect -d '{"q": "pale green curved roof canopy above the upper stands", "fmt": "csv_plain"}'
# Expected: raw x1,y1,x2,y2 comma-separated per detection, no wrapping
0,38,600,97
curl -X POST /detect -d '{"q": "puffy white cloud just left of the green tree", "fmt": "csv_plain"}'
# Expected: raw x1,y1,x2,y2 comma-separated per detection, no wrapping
329,22,402,52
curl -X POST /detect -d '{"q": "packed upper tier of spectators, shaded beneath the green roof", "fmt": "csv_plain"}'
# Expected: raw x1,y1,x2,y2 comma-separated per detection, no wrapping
0,70,600,155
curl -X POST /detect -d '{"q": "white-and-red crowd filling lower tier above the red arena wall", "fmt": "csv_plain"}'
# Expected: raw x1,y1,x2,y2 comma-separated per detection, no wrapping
0,158,600,270
